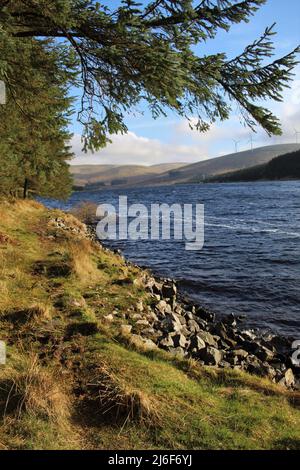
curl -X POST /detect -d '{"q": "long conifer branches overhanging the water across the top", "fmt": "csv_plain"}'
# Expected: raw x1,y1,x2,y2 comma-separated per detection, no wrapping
0,0,299,149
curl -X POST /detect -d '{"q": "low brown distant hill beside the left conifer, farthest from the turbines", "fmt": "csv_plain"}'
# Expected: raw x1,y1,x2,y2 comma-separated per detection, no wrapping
70,163,185,186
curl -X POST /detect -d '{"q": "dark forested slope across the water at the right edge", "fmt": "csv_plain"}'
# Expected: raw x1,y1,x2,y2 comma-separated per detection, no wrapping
210,150,300,182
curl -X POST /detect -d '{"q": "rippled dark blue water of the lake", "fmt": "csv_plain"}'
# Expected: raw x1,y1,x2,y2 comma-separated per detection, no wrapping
44,181,300,336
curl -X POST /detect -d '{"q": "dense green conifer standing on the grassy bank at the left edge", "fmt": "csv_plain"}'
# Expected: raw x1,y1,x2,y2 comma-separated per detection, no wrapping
0,38,76,198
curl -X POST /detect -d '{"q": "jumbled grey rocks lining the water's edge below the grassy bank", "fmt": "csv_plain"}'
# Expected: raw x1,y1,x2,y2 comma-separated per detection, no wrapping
55,220,300,390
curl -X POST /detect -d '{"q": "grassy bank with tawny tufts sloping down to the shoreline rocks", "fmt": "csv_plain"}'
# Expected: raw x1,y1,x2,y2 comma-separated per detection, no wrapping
0,202,300,449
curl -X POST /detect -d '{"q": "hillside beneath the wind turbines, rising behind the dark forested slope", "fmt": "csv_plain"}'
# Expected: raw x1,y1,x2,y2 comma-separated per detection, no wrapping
148,144,300,184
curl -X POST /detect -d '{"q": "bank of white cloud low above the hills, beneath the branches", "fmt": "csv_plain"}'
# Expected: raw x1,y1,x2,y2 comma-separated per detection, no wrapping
72,75,300,165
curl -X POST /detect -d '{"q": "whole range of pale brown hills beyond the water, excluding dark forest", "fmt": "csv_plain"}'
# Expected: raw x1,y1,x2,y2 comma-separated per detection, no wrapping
71,144,300,190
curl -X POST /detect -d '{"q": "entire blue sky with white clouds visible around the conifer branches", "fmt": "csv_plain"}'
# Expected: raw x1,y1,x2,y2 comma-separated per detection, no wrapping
71,0,300,165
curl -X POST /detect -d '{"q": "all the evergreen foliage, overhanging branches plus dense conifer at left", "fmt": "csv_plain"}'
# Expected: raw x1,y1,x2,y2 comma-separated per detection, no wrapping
0,0,300,195
